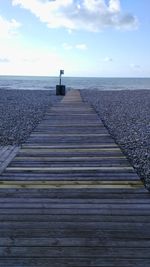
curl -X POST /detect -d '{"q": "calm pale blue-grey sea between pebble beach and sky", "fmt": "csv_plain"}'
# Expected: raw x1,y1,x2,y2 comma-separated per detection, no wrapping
0,76,150,90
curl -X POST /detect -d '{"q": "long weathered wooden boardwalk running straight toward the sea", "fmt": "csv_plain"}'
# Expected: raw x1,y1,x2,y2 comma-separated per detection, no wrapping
0,90,150,267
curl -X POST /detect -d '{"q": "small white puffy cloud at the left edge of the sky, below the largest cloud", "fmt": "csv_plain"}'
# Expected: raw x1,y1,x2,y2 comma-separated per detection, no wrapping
0,16,21,39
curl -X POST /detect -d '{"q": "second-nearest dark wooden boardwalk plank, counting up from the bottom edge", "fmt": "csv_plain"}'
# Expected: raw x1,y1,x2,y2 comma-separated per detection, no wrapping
0,247,150,259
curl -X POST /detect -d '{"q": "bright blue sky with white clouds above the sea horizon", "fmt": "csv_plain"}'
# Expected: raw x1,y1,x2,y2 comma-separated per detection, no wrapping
0,0,150,77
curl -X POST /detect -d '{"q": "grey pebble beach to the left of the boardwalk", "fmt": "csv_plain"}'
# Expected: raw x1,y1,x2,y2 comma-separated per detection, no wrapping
0,89,61,145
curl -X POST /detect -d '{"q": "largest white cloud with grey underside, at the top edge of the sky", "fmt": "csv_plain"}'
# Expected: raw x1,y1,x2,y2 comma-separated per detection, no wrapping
12,0,138,31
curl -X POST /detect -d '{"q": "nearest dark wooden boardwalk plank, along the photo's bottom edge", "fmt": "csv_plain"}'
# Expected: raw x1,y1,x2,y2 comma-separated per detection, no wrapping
0,257,150,267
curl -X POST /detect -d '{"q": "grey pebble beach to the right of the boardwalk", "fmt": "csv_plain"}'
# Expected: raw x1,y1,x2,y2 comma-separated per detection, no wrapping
81,90,150,190
